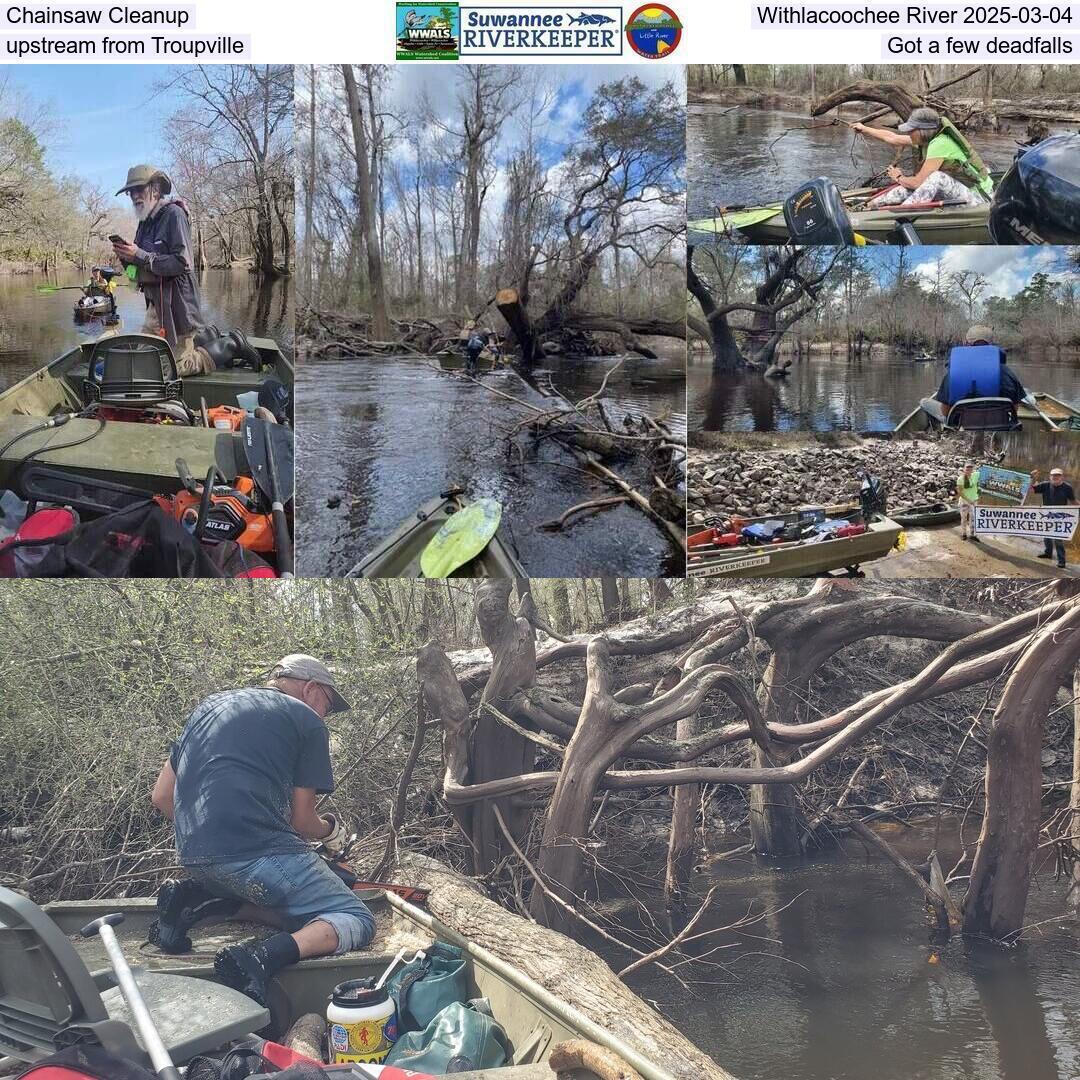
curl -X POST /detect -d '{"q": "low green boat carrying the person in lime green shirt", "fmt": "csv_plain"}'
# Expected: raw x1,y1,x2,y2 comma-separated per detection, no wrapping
688,188,990,244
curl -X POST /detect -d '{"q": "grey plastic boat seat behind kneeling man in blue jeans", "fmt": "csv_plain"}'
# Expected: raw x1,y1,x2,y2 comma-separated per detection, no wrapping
0,888,270,1065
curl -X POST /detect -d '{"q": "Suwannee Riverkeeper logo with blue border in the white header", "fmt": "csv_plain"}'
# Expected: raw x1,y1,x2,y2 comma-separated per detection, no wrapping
461,4,622,57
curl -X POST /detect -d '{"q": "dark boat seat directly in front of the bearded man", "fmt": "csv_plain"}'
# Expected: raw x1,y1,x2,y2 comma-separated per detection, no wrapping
82,334,184,408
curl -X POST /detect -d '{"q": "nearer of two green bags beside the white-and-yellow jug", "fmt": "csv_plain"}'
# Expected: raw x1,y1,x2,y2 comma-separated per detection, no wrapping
383,1001,510,1077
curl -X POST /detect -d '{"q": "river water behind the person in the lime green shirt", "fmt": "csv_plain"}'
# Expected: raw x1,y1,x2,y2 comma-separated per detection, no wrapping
687,104,1032,220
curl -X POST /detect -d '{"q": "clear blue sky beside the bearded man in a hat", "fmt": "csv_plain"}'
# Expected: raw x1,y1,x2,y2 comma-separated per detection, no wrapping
0,64,187,192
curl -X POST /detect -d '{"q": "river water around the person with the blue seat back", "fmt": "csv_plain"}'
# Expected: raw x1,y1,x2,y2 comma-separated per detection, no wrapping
687,349,1080,431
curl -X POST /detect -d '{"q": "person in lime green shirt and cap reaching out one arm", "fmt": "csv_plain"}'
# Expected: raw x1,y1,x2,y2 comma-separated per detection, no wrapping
852,108,994,208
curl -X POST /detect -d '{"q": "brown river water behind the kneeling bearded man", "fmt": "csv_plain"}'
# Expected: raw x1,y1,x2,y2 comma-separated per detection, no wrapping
0,270,293,390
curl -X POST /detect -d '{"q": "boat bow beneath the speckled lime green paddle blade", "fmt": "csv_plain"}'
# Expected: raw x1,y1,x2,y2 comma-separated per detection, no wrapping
346,488,527,578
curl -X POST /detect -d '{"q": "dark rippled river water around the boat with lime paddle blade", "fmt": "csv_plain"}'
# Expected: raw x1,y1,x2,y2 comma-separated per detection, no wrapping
297,356,686,577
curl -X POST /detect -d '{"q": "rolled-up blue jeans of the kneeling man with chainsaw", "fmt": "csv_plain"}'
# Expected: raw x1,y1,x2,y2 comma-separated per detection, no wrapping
187,851,375,955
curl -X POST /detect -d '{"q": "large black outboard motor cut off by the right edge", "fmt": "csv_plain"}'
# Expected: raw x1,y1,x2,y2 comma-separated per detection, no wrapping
989,135,1080,244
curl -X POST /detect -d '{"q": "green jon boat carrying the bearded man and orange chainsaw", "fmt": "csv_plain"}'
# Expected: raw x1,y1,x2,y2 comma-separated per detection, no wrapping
0,337,293,495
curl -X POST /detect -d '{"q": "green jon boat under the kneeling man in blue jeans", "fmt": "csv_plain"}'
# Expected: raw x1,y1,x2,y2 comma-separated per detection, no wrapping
44,892,674,1080
